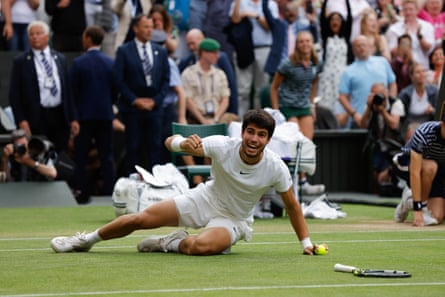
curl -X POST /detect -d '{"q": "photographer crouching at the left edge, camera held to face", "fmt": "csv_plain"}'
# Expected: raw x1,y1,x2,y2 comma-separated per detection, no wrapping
0,129,57,182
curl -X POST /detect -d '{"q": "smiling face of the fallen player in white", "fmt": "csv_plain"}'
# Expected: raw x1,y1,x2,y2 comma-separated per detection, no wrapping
240,124,270,165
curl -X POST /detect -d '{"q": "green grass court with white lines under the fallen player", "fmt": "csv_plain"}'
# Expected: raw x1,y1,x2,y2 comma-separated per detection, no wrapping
0,202,445,297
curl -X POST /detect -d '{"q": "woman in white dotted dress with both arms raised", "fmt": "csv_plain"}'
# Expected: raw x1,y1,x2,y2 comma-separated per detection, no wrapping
318,0,353,112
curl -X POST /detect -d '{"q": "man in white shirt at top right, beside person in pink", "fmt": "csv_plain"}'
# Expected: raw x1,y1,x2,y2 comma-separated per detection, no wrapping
385,0,435,68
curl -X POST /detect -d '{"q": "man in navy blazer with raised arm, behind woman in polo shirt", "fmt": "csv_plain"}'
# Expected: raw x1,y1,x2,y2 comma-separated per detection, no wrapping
262,0,318,77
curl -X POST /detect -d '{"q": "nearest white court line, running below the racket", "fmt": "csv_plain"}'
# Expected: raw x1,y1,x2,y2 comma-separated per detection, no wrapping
0,282,445,297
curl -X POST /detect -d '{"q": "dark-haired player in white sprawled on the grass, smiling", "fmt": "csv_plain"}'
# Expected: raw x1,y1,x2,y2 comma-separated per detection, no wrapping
51,110,316,255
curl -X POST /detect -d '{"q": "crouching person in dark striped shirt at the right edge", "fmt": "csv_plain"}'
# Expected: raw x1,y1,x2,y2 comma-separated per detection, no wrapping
394,114,445,226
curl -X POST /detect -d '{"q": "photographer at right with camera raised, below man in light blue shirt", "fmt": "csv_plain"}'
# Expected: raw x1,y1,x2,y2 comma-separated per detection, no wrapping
360,83,405,191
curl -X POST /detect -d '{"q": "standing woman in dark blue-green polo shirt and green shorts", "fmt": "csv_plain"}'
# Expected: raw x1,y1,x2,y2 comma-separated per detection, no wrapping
270,31,325,195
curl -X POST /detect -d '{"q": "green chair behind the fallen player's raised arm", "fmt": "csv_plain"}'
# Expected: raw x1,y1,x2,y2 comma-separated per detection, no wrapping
172,123,227,185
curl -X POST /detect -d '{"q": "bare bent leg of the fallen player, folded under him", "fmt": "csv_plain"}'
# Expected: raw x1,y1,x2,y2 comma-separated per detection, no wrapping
179,227,232,256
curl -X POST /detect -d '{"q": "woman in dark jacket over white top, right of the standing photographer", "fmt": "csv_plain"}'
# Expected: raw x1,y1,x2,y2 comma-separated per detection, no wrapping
399,63,439,138
